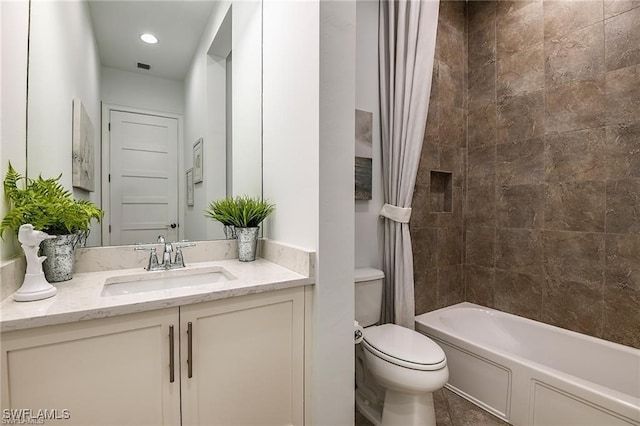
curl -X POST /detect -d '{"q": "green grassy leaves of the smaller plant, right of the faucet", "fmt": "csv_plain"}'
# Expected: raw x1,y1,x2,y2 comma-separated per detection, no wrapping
205,195,275,228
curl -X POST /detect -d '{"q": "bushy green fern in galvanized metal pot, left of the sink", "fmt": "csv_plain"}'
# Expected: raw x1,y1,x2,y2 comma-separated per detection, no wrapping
0,163,104,282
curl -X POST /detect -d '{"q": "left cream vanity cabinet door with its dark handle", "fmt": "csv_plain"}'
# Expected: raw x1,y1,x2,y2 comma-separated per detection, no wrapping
1,308,180,425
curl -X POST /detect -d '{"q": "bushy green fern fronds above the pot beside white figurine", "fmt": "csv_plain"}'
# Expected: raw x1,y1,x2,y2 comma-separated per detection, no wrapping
0,163,104,238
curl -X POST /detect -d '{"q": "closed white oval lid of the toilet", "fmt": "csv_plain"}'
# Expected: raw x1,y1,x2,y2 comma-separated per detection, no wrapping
364,324,446,370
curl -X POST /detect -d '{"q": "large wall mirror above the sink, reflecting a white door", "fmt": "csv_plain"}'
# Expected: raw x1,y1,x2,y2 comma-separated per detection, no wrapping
27,0,262,246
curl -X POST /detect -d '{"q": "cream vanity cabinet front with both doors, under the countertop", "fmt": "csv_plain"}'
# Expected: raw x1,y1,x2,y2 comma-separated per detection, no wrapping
1,287,305,426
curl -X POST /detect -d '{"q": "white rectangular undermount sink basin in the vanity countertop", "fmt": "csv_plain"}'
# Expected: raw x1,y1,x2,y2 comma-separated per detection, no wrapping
100,266,235,297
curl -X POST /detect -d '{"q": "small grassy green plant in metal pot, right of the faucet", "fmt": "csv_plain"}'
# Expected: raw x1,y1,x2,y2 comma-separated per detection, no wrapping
205,195,275,262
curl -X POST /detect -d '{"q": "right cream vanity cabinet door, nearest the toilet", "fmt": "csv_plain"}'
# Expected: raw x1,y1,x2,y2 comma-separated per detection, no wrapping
180,287,304,426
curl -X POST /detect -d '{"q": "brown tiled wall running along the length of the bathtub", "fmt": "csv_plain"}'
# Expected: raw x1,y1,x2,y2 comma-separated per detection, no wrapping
464,0,640,347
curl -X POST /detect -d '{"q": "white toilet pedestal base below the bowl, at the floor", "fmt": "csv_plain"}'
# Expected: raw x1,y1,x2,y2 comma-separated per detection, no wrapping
380,389,436,426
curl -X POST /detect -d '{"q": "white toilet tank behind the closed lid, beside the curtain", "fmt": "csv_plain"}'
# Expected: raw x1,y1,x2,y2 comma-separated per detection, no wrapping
355,268,384,327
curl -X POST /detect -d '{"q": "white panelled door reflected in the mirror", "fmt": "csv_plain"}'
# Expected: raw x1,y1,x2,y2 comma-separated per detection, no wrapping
109,110,178,244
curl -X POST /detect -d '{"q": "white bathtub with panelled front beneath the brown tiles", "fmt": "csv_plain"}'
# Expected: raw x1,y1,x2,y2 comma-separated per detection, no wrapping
416,302,640,426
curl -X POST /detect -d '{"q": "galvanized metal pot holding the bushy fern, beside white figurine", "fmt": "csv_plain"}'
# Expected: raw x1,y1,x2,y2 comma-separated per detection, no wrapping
40,234,79,283
